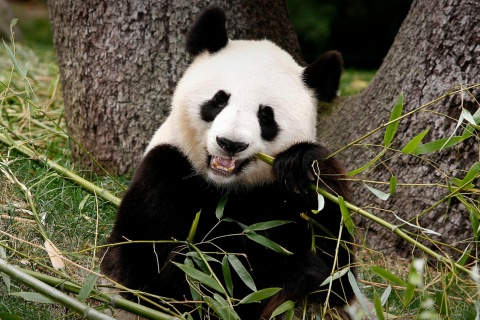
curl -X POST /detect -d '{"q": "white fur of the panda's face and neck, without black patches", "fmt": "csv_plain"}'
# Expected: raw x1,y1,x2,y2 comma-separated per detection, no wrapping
147,40,316,187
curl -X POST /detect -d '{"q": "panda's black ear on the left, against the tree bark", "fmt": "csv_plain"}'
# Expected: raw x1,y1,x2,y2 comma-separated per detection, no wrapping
187,6,228,56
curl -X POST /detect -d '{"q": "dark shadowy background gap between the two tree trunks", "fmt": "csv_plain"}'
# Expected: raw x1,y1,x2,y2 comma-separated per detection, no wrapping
287,0,412,69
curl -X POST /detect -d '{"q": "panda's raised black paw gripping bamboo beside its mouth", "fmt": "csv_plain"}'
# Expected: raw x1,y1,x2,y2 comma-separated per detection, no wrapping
273,142,330,194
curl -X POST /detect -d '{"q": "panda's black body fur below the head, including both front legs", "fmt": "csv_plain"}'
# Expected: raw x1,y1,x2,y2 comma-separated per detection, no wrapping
101,143,353,319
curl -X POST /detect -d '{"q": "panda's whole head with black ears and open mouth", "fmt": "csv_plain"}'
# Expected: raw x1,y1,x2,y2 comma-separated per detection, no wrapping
150,7,342,189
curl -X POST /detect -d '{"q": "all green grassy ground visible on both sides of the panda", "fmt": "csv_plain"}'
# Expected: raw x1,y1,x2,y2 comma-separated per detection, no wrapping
0,35,480,319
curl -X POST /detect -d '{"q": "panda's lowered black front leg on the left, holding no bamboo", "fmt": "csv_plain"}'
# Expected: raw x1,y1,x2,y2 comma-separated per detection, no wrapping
100,144,215,312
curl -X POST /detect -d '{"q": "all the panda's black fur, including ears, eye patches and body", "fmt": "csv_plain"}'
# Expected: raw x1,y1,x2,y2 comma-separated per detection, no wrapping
101,7,354,320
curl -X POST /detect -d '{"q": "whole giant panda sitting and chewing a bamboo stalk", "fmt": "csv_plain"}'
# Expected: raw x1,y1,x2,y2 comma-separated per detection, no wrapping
101,7,366,319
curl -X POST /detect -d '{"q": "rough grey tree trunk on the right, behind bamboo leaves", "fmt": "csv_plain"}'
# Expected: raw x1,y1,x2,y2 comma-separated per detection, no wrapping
319,0,480,256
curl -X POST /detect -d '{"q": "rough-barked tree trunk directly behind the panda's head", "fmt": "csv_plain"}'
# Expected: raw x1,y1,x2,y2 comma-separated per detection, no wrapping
48,0,301,174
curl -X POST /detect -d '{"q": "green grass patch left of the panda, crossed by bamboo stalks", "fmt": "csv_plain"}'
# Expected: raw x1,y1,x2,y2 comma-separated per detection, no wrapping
0,45,124,320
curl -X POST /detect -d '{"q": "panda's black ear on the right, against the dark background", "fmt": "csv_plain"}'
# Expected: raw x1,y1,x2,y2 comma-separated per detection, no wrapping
303,51,343,102
